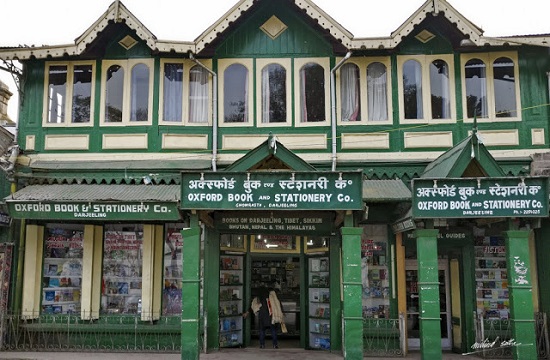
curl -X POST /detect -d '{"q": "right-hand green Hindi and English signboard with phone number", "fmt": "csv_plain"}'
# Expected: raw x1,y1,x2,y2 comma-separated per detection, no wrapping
412,177,548,219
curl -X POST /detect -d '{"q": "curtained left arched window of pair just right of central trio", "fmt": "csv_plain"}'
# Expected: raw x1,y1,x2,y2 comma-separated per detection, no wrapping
340,63,361,121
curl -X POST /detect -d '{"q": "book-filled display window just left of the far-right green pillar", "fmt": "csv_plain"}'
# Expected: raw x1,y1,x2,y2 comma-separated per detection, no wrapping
475,236,510,320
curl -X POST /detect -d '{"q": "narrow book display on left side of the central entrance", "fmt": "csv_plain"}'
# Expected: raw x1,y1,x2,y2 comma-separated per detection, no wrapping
219,255,243,347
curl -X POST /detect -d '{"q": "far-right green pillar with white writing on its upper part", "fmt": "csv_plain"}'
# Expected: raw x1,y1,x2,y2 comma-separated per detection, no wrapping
504,230,537,360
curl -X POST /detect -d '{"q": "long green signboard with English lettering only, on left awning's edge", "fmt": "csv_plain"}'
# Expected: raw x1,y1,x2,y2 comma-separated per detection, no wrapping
8,201,181,221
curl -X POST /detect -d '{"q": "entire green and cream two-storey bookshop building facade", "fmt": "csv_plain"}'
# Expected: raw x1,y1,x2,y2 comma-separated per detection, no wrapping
0,0,550,359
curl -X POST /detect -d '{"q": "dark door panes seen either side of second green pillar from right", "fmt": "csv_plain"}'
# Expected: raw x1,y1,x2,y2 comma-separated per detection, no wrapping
405,259,452,350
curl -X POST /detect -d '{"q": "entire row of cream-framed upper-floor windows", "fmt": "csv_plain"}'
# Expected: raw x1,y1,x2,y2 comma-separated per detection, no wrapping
44,53,520,126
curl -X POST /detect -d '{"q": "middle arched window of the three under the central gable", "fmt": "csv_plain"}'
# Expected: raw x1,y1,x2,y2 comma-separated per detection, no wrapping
261,64,287,123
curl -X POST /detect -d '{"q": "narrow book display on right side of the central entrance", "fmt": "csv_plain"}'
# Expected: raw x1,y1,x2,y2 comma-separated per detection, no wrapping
308,257,330,350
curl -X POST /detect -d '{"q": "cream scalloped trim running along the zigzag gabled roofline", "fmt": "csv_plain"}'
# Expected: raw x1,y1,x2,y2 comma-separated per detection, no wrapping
0,0,550,60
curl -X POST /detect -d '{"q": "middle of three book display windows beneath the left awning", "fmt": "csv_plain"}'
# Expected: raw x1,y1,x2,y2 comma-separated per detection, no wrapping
101,230,143,314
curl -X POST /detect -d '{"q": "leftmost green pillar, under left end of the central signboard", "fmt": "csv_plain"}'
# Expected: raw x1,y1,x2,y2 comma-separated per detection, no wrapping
181,215,201,360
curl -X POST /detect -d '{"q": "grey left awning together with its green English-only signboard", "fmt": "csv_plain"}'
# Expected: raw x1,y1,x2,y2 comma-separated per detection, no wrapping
5,184,181,221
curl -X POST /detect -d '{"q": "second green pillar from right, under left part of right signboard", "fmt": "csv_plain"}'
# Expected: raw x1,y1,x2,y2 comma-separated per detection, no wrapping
416,229,442,360
